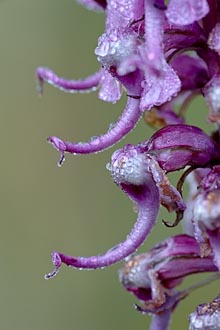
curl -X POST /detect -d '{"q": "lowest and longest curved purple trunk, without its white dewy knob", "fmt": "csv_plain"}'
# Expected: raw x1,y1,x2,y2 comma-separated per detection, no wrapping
45,165,159,279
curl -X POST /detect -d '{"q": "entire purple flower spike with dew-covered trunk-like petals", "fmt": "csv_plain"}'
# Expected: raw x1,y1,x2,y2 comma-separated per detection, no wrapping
37,0,220,330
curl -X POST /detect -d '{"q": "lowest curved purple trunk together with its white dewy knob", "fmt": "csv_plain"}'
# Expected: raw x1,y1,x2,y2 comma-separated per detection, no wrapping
46,149,159,278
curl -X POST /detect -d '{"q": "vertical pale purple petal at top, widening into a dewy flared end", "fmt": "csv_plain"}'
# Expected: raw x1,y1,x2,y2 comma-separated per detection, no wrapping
139,0,181,110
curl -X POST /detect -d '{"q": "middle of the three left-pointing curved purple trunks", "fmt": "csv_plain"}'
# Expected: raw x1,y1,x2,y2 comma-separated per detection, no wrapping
48,97,141,165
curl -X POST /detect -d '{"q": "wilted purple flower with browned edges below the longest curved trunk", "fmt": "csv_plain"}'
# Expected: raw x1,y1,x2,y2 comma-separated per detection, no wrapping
119,235,217,330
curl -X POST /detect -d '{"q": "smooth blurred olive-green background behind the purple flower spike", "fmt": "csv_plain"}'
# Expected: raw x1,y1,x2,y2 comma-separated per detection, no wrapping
0,0,218,330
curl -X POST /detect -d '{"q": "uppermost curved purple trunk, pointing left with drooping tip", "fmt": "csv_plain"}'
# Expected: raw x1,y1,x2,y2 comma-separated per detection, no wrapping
37,67,103,94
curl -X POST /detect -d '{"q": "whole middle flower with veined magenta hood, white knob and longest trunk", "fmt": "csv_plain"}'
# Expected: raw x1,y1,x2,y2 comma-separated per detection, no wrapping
46,125,217,278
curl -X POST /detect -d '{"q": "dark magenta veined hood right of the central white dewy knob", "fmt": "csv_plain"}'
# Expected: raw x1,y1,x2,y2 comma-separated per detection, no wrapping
146,124,217,172
